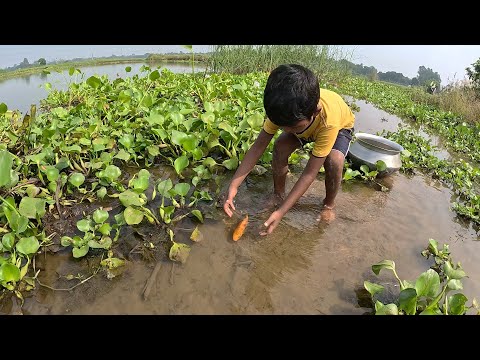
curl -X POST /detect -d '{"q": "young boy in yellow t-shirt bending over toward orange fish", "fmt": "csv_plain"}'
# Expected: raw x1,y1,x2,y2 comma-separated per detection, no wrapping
223,64,355,235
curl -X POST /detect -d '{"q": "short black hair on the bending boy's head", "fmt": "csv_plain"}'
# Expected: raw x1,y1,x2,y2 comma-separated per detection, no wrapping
263,64,320,126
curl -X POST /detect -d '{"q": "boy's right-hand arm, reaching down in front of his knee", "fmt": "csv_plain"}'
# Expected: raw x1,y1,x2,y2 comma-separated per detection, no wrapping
260,155,326,235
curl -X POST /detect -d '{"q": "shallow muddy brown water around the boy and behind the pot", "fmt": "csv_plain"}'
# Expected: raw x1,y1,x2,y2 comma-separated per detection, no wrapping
9,99,480,314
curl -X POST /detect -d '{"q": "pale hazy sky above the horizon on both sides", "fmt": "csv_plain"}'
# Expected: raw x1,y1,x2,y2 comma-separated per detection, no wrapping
0,45,480,85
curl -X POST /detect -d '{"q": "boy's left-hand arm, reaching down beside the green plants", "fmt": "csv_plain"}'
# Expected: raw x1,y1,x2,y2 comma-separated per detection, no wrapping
223,129,273,217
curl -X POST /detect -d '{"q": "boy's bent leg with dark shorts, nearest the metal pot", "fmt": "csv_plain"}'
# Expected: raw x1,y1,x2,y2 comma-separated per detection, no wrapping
320,129,353,221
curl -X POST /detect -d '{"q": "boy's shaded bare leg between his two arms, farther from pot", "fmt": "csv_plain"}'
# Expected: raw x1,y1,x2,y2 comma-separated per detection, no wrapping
272,133,302,199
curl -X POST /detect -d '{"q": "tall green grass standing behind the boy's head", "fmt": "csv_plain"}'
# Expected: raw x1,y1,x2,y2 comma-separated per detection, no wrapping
208,45,350,87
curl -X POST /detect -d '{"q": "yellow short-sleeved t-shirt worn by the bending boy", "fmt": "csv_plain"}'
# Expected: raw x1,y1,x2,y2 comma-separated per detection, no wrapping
263,89,355,157
